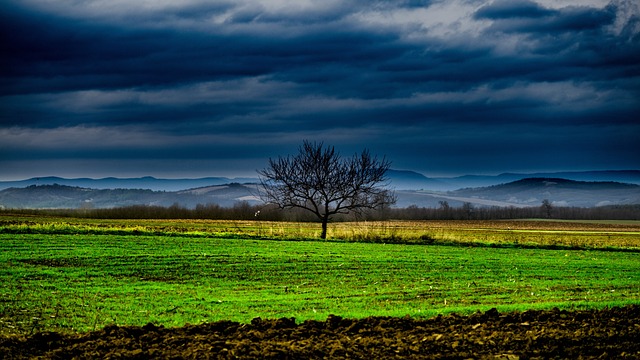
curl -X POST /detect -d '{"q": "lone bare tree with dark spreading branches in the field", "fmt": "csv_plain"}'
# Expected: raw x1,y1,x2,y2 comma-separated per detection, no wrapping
258,140,396,239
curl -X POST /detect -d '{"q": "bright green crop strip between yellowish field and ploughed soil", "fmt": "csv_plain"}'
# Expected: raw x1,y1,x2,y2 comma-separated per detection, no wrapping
0,234,640,333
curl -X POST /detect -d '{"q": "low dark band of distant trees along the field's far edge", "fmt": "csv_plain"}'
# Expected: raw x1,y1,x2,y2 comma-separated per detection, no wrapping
1,201,640,222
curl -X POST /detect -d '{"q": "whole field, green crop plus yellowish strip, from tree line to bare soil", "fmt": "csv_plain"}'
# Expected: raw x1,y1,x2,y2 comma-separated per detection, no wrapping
0,217,640,334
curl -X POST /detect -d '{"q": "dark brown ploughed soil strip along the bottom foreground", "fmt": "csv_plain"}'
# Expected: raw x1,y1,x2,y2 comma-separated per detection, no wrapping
0,305,640,359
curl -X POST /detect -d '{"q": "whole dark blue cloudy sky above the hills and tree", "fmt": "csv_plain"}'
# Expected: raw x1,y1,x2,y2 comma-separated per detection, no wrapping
0,0,640,180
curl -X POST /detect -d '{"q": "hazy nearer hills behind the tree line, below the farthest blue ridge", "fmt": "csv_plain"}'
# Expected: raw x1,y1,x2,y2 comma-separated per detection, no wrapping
0,174,640,209
